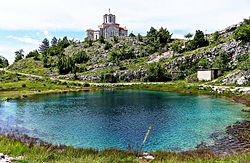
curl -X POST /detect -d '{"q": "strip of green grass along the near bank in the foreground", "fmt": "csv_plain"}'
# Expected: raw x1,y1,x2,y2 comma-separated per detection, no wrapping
0,136,250,162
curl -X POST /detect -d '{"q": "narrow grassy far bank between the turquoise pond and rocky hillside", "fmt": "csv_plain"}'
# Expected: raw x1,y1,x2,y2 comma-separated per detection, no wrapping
0,82,250,107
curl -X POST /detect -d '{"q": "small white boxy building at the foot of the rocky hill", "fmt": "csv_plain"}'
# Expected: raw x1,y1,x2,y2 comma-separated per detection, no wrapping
197,68,221,81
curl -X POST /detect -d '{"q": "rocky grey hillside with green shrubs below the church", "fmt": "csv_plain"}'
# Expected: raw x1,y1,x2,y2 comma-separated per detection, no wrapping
9,20,250,85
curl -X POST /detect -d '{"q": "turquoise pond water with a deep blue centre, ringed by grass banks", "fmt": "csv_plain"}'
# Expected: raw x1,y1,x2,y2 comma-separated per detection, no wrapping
0,90,248,151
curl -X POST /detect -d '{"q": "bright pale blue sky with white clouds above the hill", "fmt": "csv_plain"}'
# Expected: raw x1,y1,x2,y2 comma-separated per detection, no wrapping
0,0,250,63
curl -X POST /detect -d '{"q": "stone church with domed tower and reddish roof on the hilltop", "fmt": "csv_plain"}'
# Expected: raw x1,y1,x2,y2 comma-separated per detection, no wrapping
87,10,128,40
